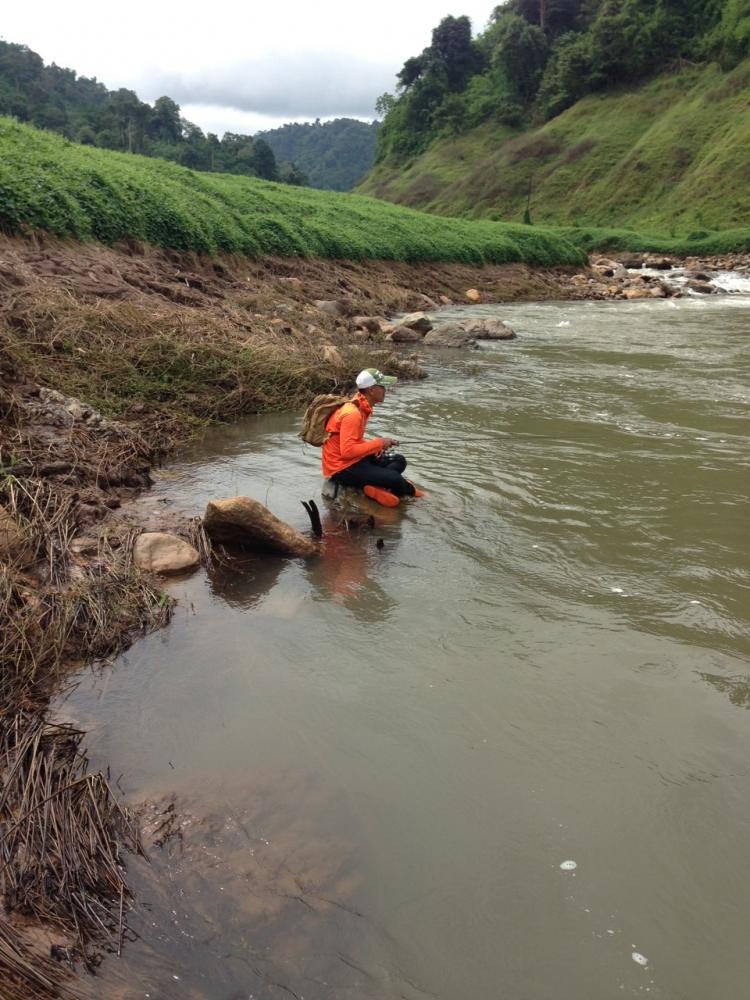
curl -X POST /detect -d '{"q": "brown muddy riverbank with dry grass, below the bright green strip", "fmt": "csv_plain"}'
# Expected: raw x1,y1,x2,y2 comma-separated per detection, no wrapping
0,232,748,997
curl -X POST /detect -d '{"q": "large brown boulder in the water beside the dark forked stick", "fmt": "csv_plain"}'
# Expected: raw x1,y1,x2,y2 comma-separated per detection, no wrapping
203,497,318,559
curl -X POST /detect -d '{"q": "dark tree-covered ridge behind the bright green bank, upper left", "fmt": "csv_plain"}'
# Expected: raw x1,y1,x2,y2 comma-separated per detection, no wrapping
0,41,306,184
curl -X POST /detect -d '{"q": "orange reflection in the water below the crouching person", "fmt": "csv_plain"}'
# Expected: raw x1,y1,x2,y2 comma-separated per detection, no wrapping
307,508,401,624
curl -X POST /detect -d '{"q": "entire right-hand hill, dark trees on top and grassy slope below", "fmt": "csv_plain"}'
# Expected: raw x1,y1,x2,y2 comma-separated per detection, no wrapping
361,0,750,231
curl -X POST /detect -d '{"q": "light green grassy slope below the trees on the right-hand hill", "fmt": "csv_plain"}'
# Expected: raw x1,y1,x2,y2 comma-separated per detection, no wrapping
358,60,750,236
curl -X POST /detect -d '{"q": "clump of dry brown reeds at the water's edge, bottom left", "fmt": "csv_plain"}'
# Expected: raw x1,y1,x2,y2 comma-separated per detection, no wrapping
0,713,141,980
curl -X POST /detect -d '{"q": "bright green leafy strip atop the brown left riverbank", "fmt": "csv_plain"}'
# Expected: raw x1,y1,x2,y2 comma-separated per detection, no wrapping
0,118,583,265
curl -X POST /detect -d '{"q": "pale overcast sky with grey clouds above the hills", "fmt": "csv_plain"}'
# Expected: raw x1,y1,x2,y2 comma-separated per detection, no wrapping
5,0,498,135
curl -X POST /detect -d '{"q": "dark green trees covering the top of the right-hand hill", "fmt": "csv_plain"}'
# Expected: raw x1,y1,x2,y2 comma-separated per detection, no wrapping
378,0,750,162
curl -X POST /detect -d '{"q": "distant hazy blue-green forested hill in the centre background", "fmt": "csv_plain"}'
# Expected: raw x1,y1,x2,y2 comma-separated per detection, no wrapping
255,118,380,191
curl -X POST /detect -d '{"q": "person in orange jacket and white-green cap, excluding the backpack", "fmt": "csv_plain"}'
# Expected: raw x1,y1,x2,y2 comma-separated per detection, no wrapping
322,368,424,507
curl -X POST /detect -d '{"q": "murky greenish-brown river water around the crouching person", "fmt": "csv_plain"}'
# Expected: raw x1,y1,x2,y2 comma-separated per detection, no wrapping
60,298,750,1000
